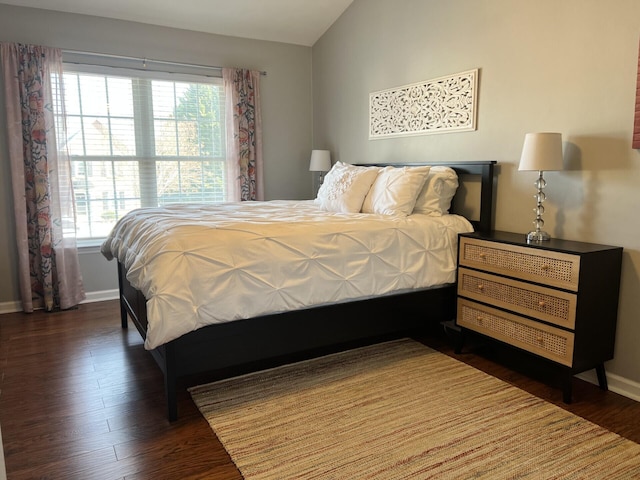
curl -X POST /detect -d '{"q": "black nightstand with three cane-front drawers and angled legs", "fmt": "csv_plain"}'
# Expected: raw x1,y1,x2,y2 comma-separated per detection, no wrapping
456,231,622,403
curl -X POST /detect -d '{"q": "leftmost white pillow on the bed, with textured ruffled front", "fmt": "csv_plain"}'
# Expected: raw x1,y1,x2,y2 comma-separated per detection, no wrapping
315,162,380,213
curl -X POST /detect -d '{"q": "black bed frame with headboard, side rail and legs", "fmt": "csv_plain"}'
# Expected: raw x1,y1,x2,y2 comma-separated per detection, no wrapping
118,161,495,421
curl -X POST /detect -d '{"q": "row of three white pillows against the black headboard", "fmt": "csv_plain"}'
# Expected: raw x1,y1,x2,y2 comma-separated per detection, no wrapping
315,162,458,216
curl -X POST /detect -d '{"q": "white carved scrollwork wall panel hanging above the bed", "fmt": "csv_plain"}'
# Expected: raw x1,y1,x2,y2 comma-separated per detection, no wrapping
369,69,478,139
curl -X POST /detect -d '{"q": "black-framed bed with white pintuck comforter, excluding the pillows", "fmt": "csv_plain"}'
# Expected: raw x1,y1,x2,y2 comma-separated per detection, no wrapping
102,161,495,421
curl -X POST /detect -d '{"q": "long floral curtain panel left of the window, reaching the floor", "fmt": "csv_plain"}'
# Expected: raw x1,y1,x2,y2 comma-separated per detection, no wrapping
0,43,85,312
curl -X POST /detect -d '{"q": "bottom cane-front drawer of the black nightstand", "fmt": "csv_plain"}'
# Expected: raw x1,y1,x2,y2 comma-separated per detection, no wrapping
457,298,574,367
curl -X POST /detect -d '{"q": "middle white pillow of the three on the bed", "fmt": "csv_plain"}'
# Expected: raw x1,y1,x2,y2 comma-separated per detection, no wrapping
362,166,431,216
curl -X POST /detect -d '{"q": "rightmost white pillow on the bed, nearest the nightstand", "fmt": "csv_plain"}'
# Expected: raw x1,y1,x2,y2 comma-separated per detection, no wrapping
413,166,458,217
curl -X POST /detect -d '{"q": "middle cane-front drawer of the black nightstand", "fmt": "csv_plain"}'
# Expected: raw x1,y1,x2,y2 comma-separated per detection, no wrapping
458,267,577,329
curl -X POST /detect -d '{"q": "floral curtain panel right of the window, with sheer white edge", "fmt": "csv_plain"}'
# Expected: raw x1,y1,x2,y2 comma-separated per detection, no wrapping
222,68,264,201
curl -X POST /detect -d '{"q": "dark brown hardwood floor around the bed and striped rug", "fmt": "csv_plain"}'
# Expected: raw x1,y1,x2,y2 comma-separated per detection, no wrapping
0,301,640,480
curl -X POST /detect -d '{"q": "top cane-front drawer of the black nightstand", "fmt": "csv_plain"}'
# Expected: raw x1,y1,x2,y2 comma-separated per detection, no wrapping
459,237,580,292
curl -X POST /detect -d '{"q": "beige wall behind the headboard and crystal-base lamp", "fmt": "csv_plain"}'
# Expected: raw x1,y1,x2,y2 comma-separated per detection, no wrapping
313,0,640,386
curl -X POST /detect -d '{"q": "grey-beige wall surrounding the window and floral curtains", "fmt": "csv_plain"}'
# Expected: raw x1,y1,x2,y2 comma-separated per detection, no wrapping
0,2,312,305
